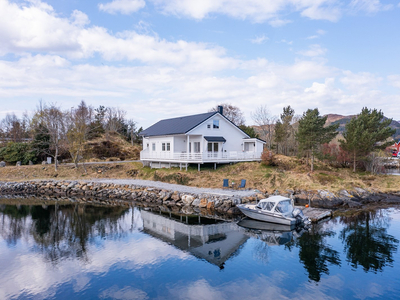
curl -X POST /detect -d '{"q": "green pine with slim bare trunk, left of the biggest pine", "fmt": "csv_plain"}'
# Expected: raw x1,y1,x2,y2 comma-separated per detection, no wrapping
296,108,339,172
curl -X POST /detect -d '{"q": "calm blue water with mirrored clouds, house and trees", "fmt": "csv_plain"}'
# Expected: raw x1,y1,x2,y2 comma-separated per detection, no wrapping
0,199,400,300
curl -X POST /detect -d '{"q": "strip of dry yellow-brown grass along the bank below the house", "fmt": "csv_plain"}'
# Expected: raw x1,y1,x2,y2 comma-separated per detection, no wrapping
0,156,400,192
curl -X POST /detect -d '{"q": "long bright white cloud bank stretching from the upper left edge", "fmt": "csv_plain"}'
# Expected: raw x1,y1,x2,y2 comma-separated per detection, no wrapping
0,0,237,71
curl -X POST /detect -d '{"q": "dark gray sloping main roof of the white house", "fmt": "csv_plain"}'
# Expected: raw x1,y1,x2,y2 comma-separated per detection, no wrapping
140,111,217,136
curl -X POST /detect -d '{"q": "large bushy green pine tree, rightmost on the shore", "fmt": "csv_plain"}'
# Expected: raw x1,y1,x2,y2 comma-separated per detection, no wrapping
340,107,395,172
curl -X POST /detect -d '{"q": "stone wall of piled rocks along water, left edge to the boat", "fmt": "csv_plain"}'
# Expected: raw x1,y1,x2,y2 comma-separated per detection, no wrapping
0,181,265,215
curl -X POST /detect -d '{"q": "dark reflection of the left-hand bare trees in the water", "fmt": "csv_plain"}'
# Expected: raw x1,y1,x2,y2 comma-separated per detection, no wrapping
0,203,129,263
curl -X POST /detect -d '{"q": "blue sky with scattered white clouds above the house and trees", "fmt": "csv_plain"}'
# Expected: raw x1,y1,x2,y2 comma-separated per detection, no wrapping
0,0,400,128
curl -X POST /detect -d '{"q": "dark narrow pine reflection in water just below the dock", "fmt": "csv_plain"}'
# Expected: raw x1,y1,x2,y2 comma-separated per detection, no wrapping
296,224,341,282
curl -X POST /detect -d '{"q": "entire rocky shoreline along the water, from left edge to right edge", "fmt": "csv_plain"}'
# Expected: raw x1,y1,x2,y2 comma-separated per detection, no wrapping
0,180,400,215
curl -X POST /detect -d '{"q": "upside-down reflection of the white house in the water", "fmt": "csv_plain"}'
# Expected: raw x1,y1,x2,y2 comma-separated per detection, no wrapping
141,210,249,268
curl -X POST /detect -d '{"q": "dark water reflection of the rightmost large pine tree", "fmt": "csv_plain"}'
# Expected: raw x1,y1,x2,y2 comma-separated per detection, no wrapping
340,210,399,273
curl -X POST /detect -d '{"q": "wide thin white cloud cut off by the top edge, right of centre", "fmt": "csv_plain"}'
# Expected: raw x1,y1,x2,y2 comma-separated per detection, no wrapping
151,0,340,22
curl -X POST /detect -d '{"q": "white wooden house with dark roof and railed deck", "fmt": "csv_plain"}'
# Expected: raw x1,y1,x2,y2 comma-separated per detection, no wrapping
140,106,265,170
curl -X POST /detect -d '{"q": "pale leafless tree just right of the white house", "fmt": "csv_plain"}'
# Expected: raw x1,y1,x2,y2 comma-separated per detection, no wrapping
251,105,277,149
